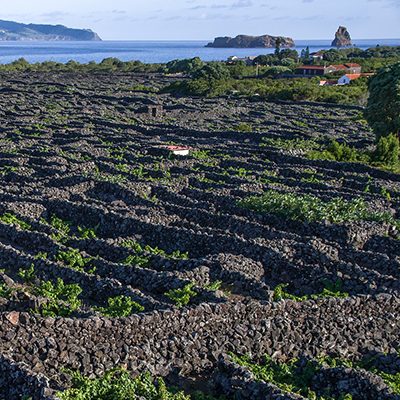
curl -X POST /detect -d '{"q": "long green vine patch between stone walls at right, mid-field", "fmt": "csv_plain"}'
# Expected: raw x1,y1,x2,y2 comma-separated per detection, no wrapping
238,190,398,224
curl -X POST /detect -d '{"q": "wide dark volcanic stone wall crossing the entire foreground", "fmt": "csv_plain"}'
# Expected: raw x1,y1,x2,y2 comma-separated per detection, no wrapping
0,294,400,398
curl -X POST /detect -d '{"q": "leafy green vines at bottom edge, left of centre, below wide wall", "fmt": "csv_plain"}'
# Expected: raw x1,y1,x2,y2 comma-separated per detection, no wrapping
57,369,190,400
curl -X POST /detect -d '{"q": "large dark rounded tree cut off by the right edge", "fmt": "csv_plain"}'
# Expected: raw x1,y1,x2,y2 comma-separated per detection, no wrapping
365,62,400,138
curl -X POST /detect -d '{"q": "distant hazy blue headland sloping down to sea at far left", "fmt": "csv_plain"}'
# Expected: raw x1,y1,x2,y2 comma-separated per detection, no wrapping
0,20,101,41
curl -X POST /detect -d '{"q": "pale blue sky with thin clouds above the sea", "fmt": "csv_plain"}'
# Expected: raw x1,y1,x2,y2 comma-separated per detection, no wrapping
0,0,400,40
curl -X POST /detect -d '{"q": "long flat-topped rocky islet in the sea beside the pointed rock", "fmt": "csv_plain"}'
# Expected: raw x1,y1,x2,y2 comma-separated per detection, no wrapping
206,35,295,48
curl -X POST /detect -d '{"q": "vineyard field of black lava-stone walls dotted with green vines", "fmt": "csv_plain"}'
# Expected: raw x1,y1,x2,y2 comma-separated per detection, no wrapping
0,73,400,400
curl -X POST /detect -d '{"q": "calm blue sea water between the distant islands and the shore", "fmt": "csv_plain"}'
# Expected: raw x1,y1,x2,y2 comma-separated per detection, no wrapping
0,39,400,64
